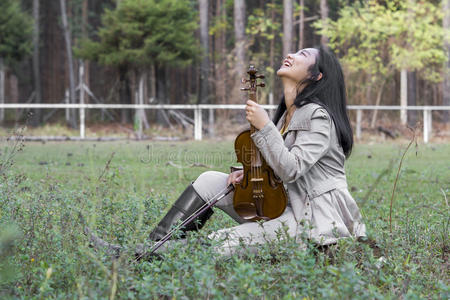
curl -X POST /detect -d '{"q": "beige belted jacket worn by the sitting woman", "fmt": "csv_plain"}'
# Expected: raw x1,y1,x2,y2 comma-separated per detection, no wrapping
251,103,366,245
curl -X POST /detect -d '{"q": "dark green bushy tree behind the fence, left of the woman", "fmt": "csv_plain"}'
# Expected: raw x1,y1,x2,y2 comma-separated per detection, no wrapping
75,0,201,124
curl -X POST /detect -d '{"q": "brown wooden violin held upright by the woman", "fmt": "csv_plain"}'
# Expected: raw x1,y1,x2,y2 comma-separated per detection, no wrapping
233,65,288,221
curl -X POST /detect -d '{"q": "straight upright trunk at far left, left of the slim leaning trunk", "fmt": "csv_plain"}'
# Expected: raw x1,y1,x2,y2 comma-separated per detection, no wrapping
31,0,42,126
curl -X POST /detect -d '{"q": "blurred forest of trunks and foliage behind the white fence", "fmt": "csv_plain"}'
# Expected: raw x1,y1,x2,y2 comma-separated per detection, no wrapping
0,0,450,135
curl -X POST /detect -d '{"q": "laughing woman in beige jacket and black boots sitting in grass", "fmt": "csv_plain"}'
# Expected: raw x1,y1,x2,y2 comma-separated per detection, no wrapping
83,47,366,256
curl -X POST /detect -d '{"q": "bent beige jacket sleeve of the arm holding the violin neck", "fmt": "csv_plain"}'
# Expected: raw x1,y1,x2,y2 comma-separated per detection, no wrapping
250,108,331,183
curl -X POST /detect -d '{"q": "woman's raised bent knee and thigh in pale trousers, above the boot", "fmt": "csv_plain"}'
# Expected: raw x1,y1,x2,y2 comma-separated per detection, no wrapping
192,171,247,224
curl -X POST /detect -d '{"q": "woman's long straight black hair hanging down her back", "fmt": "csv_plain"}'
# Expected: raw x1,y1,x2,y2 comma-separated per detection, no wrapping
273,46,353,157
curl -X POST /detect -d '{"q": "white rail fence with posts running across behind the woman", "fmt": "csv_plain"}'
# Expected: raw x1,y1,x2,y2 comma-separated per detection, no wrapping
0,103,450,143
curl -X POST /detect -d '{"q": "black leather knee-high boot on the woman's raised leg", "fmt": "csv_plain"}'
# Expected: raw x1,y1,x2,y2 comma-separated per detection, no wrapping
149,182,213,241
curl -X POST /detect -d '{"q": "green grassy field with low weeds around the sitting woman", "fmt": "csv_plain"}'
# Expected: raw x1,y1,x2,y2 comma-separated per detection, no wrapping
0,141,450,299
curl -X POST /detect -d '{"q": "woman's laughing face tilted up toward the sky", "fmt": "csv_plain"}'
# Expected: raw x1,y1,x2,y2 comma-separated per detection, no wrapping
277,48,319,82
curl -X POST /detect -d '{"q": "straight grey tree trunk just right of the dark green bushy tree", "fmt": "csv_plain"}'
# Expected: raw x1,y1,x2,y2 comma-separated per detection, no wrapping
197,0,209,104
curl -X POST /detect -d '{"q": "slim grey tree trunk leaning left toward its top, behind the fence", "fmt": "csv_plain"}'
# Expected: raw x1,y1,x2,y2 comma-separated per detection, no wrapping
60,0,77,128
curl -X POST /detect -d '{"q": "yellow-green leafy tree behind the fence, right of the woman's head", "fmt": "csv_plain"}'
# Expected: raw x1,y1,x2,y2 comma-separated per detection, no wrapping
315,0,447,125
